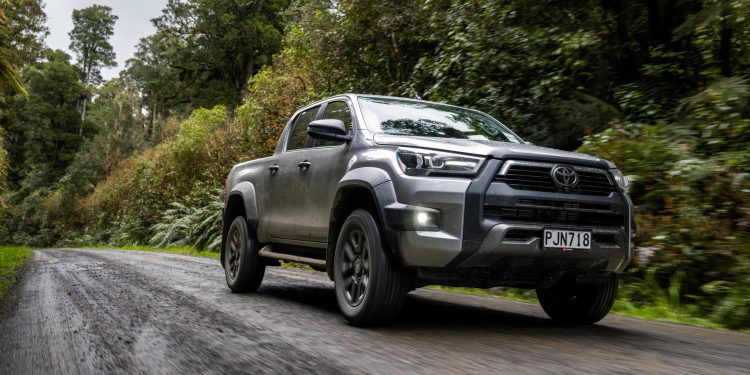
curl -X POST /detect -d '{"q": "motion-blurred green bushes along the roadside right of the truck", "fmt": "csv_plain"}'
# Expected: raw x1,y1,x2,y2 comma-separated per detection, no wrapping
579,72,750,328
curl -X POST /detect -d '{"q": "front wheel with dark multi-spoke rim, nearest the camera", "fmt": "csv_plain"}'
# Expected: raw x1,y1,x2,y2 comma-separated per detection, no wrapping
334,210,410,326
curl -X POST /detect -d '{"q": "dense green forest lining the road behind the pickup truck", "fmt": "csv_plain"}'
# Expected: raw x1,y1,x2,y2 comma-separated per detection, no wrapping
0,0,750,328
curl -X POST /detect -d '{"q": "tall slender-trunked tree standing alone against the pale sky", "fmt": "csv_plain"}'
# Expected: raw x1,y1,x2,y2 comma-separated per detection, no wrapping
68,5,118,129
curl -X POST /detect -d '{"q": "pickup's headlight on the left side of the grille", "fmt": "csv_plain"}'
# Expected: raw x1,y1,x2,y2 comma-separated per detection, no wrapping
396,148,484,176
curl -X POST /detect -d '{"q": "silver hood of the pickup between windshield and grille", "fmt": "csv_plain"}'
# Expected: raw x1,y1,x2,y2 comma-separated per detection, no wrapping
373,133,615,168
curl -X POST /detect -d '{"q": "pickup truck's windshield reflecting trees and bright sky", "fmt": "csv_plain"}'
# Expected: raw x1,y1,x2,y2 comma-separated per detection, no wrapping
359,97,522,143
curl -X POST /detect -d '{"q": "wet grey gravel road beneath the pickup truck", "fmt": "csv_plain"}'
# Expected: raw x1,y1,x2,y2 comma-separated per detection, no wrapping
0,249,750,375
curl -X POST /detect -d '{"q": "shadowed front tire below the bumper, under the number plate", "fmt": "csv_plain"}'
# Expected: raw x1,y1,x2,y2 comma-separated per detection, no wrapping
536,274,620,324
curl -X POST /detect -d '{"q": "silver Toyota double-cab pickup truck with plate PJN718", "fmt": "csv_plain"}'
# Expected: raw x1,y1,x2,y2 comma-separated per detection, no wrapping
221,94,635,326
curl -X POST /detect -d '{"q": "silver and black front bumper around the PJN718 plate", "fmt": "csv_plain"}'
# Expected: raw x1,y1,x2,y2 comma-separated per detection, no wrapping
393,159,634,272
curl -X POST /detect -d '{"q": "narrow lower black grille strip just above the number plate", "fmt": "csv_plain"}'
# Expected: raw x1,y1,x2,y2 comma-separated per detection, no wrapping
484,201,625,227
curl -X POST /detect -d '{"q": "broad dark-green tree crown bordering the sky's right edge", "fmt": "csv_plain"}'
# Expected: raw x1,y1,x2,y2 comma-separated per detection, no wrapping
127,0,288,112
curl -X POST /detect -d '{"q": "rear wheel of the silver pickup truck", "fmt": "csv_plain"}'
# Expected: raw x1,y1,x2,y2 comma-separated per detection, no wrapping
224,216,266,293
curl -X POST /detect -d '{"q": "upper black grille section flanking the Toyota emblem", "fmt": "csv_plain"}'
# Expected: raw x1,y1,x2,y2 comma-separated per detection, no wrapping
495,161,616,196
